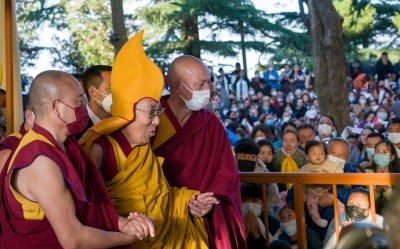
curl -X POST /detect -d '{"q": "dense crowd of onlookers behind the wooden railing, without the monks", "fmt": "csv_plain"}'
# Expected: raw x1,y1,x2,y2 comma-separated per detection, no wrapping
209,53,400,248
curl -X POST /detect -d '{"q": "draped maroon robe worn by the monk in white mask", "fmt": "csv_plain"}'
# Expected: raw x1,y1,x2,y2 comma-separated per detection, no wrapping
154,100,246,249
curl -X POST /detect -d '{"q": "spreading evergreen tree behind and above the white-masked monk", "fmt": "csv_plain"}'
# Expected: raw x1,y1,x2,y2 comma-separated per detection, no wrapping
137,0,303,72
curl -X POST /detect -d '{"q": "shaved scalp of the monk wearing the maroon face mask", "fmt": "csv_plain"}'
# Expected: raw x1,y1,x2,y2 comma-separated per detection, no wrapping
29,70,79,118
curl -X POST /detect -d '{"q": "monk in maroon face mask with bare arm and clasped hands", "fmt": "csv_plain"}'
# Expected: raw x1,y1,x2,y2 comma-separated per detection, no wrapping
0,71,154,248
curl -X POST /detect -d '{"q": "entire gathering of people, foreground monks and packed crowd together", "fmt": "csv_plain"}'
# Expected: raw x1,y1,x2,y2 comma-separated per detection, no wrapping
0,28,400,249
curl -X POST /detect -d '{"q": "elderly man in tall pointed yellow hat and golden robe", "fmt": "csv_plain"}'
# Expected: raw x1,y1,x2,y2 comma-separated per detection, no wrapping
80,31,219,248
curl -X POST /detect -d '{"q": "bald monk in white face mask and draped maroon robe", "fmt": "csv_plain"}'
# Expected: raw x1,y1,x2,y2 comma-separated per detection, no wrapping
152,55,246,249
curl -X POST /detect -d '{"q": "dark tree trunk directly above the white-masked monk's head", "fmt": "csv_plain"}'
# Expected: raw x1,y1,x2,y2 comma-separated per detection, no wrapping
182,18,200,59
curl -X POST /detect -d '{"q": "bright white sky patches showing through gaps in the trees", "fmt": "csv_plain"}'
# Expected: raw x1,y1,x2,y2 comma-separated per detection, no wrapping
21,0,299,77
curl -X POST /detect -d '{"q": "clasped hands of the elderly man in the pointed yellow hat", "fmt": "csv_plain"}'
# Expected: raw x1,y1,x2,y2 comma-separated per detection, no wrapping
188,192,219,218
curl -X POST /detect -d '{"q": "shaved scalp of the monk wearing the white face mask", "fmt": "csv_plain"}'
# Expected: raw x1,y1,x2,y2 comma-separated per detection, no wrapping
167,55,209,90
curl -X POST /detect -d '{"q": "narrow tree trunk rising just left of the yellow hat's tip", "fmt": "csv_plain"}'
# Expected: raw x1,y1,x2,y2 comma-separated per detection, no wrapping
110,0,128,56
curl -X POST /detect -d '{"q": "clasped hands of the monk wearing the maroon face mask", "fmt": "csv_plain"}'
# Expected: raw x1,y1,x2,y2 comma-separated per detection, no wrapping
120,212,155,240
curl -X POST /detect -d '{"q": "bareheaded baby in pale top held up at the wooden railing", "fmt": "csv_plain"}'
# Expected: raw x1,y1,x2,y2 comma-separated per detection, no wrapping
298,141,344,227
